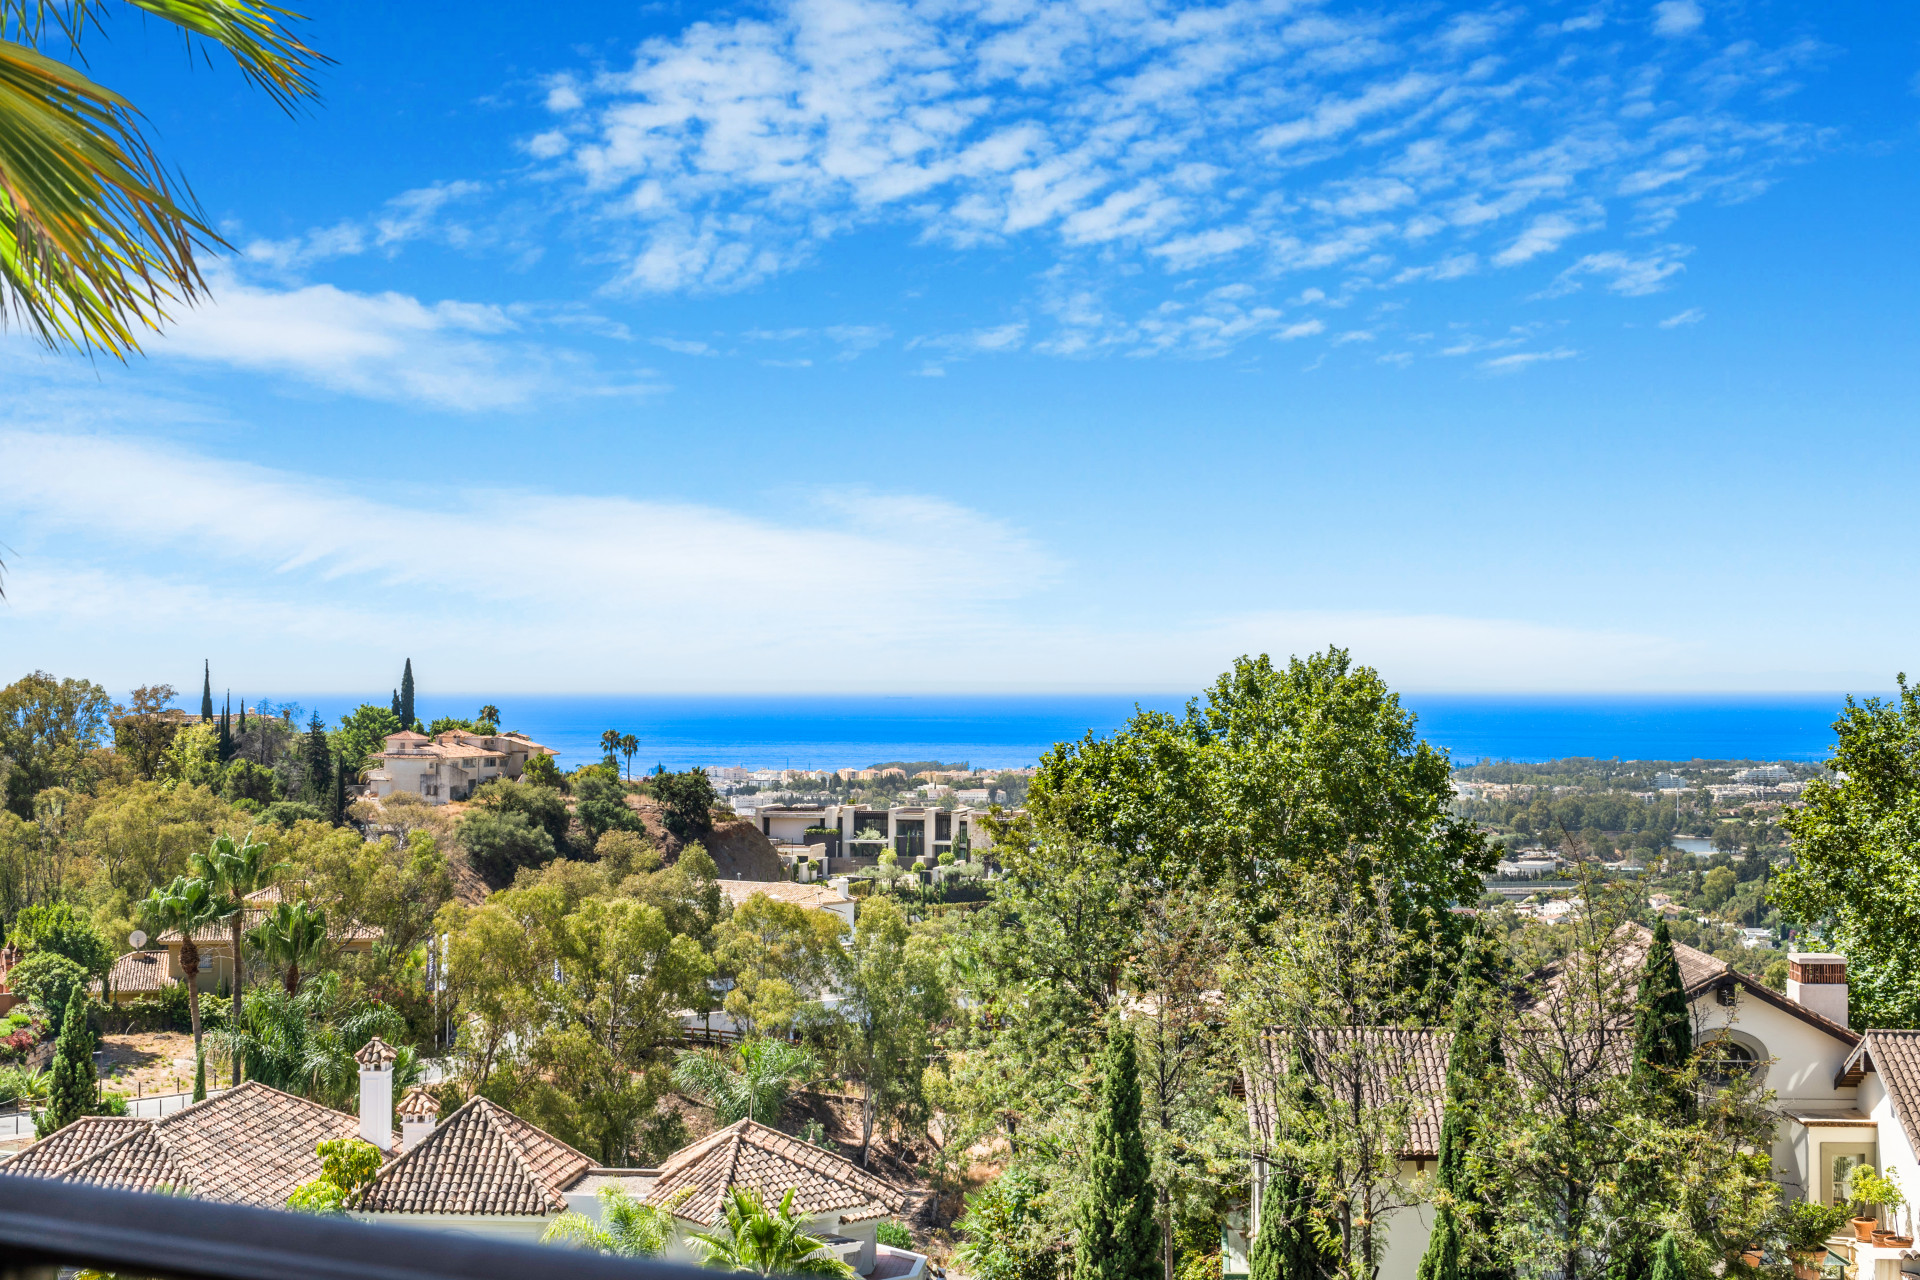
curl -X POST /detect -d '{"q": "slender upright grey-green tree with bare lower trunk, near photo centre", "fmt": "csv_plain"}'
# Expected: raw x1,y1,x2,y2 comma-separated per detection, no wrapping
839,898,948,1167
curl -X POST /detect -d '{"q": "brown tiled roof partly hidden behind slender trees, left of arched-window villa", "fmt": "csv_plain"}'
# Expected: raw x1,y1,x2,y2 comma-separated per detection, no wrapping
1246,1027,1453,1159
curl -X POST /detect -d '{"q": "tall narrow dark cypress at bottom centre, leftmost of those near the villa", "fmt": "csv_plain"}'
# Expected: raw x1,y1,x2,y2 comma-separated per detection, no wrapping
1073,1025,1162,1280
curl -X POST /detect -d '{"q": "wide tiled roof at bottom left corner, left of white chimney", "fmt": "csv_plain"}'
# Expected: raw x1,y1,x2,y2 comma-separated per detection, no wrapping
6,1080,359,1209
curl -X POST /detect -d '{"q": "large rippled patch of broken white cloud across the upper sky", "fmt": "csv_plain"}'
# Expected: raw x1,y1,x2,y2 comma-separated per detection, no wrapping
528,0,1820,355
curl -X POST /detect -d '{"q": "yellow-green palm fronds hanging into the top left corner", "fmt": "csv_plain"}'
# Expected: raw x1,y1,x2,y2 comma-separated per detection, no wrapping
0,0,326,359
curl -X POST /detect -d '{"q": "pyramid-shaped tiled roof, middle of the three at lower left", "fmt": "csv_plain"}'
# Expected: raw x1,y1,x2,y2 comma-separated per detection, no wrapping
355,1098,593,1215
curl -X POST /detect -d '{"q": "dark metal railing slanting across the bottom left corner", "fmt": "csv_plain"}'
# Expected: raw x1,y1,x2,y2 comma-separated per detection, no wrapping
0,1174,712,1280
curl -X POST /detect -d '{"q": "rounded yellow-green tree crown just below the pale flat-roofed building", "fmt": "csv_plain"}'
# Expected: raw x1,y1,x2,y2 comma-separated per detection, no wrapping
714,894,847,1034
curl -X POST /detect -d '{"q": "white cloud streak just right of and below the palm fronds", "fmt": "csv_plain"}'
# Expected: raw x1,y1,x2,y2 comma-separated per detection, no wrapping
148,273,639,411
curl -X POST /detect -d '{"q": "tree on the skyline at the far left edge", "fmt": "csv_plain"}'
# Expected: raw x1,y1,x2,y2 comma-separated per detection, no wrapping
0,675,113,818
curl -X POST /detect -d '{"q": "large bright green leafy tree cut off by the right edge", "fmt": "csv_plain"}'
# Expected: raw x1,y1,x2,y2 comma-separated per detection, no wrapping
1772,674,1920,1027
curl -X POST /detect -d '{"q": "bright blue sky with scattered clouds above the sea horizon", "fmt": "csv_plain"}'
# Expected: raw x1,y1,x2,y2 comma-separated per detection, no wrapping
0,0,1920,691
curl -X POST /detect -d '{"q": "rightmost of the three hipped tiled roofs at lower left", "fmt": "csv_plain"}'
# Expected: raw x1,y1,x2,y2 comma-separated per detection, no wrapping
647,1121,899,1224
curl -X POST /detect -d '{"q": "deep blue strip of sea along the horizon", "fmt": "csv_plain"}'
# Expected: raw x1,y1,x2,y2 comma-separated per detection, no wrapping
266,689,1843,770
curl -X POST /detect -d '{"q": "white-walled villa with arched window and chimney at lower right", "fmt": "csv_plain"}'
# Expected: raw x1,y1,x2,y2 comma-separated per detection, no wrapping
1221,925,1920,1280
